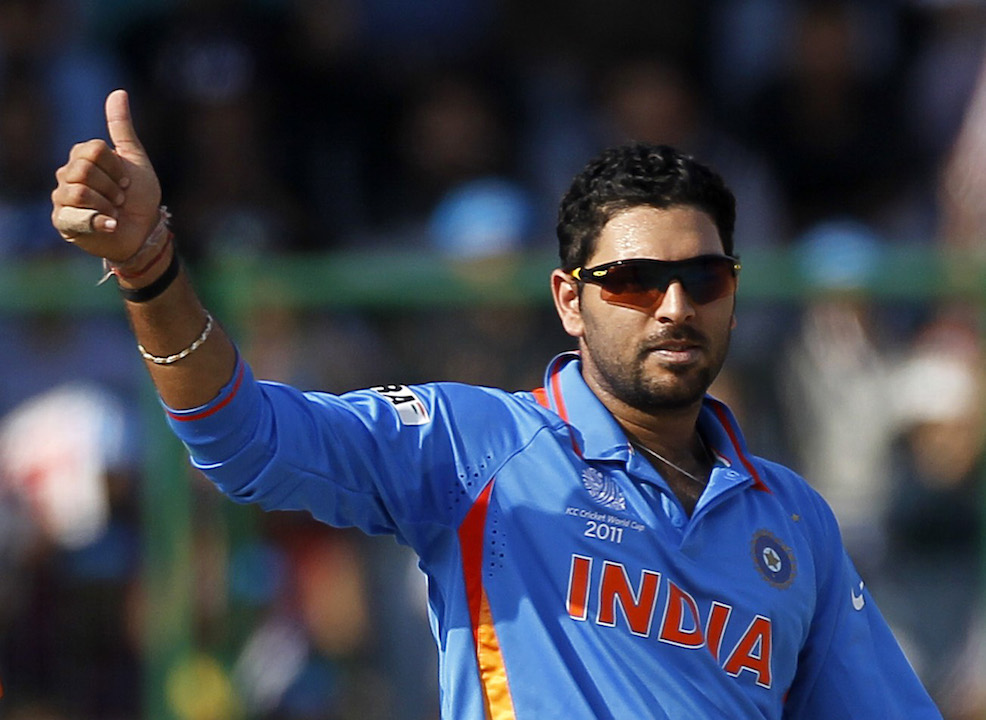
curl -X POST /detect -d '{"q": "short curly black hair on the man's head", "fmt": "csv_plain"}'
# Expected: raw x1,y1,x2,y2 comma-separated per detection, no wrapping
556,143,736,271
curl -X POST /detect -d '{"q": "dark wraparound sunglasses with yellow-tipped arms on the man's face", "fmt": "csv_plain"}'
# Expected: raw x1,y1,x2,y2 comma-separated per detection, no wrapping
571,255,740,311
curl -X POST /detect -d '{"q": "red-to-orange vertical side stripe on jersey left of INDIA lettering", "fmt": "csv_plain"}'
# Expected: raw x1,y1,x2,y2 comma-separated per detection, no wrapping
459,480,515,720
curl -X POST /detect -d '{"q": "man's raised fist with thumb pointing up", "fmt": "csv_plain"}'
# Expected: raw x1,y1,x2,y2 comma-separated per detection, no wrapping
51,90,161,262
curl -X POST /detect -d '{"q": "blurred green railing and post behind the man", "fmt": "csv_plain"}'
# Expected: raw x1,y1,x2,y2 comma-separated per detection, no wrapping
0,248,986,720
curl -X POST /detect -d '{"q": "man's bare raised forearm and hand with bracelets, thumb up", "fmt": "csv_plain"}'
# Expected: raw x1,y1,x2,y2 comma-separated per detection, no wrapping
51,90,235,409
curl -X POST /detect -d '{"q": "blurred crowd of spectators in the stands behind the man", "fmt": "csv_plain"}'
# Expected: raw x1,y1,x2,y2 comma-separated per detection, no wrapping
0,0,986,720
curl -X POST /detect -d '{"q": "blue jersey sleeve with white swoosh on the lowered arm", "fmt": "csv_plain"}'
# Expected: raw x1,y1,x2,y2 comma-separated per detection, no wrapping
784,499,941,720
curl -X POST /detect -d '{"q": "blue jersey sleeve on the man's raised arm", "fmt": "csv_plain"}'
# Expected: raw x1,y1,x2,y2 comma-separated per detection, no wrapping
166,360,504,547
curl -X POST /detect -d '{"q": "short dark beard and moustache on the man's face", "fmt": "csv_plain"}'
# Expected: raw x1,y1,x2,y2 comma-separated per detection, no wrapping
582,327,731,413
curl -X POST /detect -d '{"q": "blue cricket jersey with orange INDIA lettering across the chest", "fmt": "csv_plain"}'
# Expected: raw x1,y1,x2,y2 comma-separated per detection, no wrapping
168,354,941,720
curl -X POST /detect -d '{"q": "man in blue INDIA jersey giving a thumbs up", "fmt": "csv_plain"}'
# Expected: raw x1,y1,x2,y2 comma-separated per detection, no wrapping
52,91,940,720
